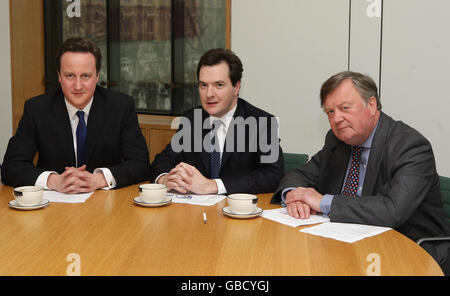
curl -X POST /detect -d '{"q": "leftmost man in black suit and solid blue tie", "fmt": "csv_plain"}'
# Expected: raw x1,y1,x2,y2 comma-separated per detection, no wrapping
2,38,149,193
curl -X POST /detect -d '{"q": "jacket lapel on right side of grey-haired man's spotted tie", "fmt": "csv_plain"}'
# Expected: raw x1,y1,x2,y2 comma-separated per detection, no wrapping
362,112,389,195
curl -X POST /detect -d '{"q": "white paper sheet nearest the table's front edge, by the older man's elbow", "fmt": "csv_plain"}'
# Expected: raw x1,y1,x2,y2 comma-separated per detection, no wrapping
300,222,392,243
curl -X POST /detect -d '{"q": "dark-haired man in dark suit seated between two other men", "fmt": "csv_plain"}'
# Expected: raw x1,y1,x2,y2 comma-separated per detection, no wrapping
151,49,283,194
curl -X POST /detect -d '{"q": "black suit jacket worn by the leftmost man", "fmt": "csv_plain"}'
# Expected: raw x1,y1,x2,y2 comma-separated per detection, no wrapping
2,86,150,187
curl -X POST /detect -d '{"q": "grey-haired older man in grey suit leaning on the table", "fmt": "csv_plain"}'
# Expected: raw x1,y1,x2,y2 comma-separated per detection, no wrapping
273,71,450,274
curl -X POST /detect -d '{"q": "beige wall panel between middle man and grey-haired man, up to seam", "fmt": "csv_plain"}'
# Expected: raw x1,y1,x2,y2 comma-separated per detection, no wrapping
231,0,349,162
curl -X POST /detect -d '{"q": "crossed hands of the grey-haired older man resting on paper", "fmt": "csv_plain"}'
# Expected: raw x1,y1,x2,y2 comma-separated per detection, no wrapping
285,187,322,219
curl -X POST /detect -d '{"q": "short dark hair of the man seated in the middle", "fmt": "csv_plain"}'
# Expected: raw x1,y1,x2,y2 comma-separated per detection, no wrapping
197,48,244,86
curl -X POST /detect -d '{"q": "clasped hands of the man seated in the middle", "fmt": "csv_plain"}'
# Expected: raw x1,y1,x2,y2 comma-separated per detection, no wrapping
158,162,217,194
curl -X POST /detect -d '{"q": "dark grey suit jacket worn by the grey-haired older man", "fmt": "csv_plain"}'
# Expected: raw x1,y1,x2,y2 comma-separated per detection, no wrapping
272,112,450,262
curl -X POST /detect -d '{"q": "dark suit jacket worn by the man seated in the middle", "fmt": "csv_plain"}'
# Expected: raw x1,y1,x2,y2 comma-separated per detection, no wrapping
150,99,283,194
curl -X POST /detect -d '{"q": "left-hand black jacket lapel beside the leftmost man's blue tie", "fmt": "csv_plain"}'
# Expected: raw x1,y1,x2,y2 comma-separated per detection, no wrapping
51,90,76,166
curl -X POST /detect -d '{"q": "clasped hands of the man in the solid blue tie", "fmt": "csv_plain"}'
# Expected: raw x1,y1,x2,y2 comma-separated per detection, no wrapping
47,165,107,194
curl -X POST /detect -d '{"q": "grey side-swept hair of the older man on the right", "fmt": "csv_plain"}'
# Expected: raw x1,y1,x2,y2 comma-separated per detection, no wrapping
320,71,381,110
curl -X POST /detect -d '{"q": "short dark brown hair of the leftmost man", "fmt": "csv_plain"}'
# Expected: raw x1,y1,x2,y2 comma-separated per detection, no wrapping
56,37,102,75
